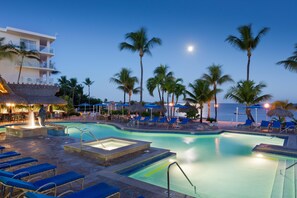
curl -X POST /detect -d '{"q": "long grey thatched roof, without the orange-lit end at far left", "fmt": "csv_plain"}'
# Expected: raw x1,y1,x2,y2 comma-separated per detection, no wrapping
8,84,67,104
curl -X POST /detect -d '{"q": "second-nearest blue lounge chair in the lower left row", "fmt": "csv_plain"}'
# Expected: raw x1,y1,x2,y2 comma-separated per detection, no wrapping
0,171,84,197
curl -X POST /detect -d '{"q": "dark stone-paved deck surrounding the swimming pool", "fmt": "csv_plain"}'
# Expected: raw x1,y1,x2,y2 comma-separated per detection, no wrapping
0,120,297,198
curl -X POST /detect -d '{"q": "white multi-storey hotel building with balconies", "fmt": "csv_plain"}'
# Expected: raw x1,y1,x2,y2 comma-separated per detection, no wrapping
0,27,56,85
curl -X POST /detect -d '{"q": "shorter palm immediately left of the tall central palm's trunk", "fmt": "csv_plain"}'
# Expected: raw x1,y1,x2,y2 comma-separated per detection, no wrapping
110,68,138,103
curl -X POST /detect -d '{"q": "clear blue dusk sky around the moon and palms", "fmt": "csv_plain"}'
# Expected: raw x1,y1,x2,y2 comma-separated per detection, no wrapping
0,0,297,103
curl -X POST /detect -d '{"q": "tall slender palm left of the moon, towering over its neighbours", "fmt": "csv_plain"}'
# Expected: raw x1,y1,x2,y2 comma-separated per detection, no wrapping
120,27,162,102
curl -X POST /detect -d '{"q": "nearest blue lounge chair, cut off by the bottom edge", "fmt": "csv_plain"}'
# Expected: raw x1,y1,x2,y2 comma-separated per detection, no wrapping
25,182,120,198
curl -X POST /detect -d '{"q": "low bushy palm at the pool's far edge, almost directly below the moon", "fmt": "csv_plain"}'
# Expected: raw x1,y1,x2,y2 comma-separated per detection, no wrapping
185,79,214,123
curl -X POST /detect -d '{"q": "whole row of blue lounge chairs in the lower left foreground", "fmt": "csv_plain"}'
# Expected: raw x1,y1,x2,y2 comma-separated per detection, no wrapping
0,147,120,198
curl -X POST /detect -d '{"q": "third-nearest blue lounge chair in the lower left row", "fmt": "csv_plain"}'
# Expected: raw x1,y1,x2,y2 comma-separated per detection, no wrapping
0,163,57,179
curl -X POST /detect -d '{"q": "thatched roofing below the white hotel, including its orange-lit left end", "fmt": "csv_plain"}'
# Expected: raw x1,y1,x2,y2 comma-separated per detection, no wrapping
0,76,67,104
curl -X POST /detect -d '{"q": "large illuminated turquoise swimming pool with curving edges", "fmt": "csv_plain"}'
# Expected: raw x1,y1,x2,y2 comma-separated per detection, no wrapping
63,123,284,198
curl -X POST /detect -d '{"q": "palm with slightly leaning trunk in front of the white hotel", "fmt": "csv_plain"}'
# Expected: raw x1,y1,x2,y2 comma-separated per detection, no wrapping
13,42,40,84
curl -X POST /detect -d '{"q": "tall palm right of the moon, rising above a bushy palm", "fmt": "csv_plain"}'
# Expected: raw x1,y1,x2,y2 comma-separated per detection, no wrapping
225,25,269,80
